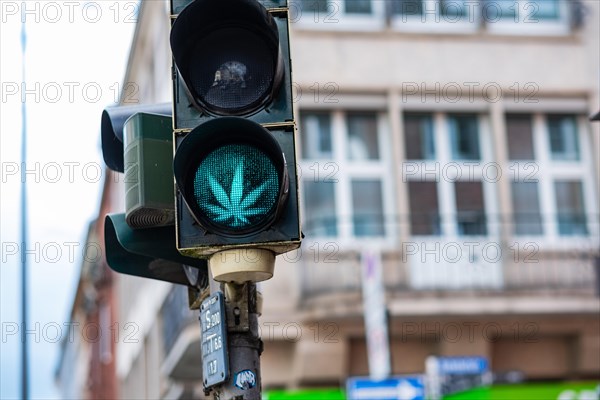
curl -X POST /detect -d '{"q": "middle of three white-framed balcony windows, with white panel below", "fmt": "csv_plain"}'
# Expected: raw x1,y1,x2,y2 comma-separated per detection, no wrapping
401,111,504,289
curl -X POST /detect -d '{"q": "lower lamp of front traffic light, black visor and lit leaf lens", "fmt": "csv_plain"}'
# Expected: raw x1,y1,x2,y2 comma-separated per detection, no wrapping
174,117,288,235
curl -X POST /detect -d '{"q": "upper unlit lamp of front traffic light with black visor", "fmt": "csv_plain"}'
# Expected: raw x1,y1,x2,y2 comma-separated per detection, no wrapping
171,0,283,115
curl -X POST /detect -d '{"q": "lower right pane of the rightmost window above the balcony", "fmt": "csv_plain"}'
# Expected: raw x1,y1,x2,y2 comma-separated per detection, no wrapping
554,181,588,235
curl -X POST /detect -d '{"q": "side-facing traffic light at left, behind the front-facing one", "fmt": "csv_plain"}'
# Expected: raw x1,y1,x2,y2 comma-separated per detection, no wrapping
101,104,208,287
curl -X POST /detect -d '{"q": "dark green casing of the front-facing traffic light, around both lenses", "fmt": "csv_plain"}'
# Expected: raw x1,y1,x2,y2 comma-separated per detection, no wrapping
170,0,302,257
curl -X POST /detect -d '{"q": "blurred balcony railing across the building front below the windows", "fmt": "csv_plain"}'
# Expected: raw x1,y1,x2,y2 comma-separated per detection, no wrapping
296,215,600,299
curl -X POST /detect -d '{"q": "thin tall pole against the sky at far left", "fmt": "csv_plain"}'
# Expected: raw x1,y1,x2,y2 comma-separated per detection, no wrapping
21,14,29,400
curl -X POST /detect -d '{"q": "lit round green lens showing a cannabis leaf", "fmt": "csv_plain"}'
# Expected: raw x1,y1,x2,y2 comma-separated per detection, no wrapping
193,144,280,233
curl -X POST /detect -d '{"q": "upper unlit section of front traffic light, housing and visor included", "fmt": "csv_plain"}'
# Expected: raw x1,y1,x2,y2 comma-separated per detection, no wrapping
170,0,294,126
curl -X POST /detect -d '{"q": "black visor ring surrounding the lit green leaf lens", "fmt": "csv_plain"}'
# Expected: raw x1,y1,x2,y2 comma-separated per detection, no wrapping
173,117,289,237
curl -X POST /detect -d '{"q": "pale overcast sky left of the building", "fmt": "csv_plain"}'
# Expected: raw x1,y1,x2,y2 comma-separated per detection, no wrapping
0,0,138,400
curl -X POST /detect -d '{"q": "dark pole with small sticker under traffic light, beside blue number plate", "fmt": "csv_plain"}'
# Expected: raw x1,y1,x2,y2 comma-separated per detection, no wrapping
205,279,263,400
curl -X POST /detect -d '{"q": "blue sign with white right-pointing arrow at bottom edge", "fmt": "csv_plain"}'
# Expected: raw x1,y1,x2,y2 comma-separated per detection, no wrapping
346,376,425,400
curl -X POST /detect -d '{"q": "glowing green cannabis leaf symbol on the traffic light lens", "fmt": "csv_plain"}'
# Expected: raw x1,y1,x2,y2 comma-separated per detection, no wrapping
206,159,273,227
